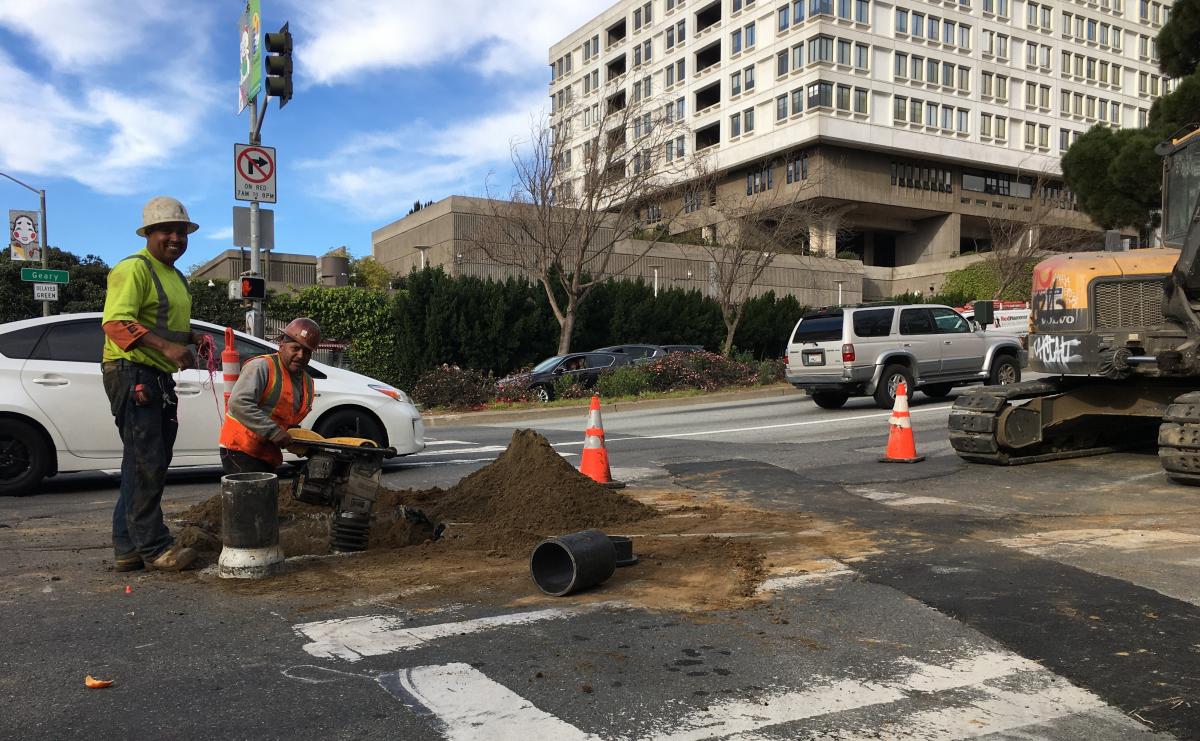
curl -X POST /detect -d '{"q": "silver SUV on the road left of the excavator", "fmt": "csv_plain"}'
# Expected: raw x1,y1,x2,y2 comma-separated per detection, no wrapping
787,303,1026,409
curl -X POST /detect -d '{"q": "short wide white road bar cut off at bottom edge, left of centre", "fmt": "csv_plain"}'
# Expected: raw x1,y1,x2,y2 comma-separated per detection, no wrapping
378,663,599,741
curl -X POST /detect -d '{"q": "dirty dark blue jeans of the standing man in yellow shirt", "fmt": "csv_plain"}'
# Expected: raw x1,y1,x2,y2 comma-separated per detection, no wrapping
102,360,179,560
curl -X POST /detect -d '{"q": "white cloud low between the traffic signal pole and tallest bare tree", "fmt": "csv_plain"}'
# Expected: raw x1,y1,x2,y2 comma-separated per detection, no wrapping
300,90,546,219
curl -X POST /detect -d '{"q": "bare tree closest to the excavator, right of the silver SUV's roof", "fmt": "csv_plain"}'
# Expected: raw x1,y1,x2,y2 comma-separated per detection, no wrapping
986,174,1097,300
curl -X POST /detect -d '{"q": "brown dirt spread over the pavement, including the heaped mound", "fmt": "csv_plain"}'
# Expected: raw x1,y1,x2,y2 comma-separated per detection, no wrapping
179,430,871,610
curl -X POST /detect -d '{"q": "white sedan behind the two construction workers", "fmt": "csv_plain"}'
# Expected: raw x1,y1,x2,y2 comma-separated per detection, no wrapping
0,313,425,495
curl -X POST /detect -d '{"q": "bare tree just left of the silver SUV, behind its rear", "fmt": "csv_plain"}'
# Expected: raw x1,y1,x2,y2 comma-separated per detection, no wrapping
690,153,839,356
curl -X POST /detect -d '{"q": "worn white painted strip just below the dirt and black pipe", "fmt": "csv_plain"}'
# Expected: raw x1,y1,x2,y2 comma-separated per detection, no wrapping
294,602,612,661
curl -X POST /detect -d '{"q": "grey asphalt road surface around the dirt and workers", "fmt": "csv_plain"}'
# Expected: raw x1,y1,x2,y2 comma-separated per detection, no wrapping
0,394,1200,740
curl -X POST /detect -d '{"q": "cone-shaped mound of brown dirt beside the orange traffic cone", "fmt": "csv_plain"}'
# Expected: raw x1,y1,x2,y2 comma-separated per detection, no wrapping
376,429,658,553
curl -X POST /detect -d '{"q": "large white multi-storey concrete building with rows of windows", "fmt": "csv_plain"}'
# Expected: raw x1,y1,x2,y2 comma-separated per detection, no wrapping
550,0,1170,274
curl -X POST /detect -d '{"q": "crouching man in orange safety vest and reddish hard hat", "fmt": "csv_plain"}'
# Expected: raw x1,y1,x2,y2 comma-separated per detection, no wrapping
221,317,320,474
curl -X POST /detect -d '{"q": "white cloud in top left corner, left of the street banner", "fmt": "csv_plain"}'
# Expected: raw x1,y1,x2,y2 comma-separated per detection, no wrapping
0,0,218,193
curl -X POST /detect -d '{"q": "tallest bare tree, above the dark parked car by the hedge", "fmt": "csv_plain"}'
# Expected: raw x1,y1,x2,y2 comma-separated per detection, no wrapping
468,85,688,354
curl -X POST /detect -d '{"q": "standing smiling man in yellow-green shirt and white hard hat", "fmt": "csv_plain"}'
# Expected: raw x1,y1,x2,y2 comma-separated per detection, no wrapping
101,195,200,571
